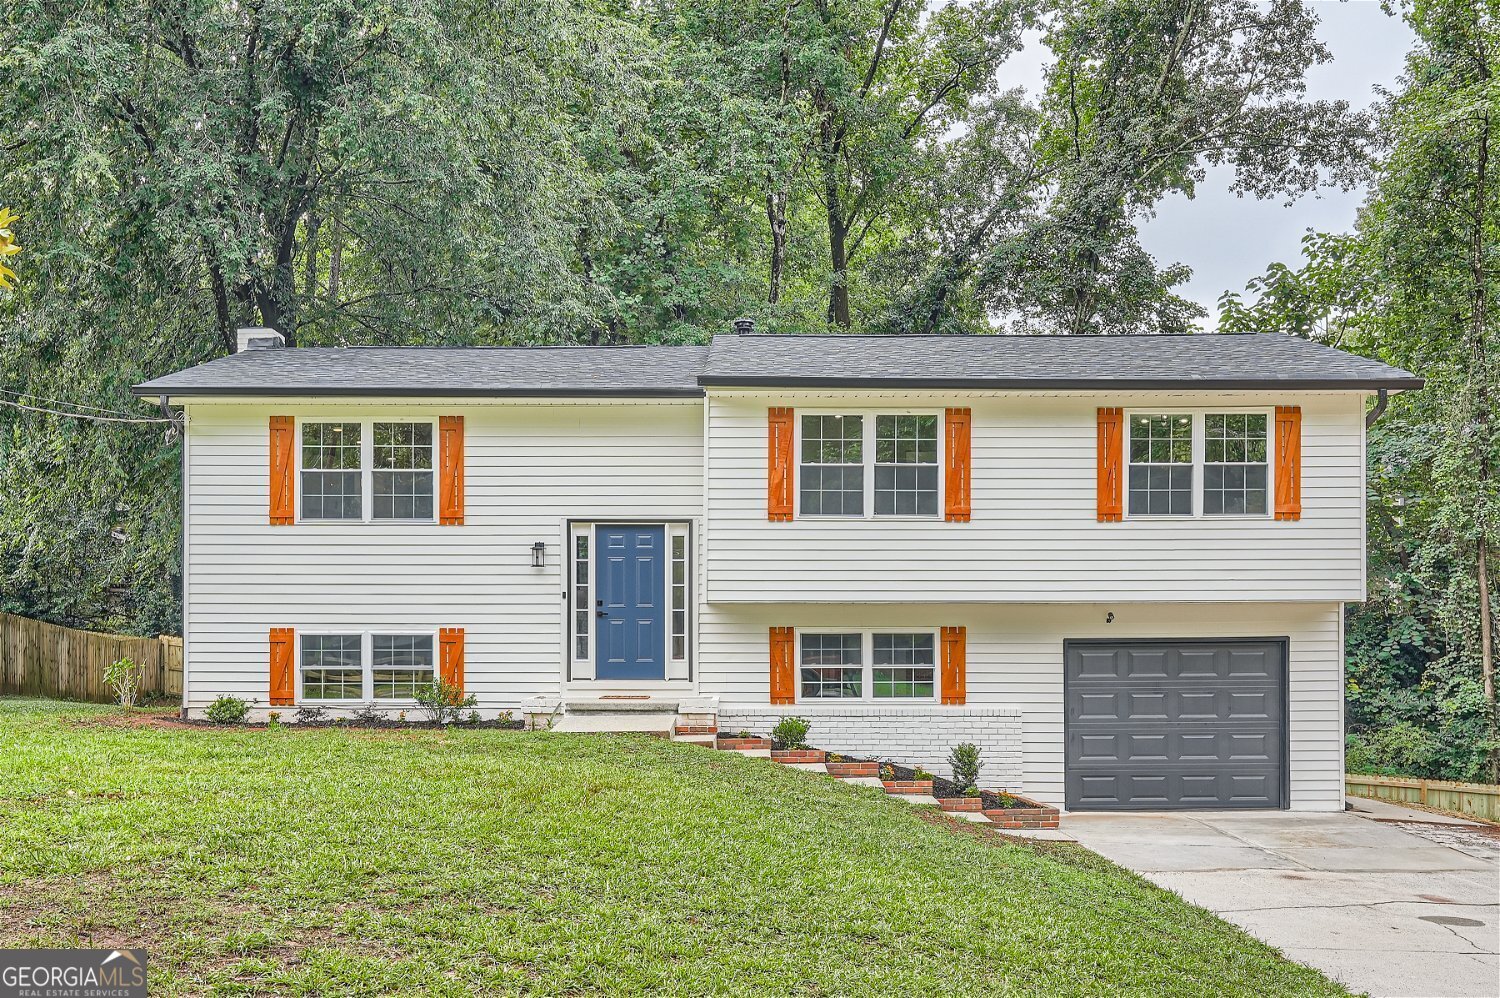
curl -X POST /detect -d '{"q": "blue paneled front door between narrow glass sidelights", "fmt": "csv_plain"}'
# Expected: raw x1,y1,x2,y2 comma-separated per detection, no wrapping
594,524,666,680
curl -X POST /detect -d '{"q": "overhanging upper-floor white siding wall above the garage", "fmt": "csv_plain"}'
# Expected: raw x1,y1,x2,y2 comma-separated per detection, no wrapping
707,392,1365,602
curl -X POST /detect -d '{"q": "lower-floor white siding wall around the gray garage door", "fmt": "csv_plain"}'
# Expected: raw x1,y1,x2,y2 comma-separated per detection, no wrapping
699,602,1344,810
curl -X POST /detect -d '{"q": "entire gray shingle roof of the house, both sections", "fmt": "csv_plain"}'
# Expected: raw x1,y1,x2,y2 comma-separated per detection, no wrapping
135,333,1422,398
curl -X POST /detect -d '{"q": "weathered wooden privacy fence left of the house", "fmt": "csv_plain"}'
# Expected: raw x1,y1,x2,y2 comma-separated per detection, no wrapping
0,614,183,704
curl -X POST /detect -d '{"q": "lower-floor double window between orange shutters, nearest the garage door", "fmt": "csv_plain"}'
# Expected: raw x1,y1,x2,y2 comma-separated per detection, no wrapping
798,630,938,701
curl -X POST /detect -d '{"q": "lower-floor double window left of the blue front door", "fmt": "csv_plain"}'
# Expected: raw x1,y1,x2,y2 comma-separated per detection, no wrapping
299,633,437,701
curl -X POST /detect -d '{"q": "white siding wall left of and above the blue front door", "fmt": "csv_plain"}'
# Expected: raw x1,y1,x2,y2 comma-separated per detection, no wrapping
185,399,704,710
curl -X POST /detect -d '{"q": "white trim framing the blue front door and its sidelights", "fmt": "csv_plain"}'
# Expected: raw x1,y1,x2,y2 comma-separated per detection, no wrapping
567,516,698,686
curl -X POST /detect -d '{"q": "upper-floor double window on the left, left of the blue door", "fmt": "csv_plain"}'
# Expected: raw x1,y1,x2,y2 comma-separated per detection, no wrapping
299,420,437,522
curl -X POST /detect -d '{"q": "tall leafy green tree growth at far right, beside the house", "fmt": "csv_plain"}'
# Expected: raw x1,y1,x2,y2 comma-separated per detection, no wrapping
1224,0,1500,780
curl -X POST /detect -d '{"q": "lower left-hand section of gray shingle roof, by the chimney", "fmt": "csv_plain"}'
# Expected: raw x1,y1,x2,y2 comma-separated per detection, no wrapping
135,347,708,398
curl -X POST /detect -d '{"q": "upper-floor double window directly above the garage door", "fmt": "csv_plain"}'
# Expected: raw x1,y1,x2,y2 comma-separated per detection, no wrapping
1127,413,1271,518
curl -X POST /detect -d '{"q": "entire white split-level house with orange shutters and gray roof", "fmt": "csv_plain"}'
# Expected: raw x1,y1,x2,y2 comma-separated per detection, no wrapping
137,332,1421,810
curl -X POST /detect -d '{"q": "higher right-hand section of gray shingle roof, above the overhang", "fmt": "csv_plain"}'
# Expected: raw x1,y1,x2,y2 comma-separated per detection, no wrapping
699,333,1422,389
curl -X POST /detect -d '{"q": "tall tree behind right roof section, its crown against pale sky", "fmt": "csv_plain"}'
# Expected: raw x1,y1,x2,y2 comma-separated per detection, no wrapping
978,0,1364,333
